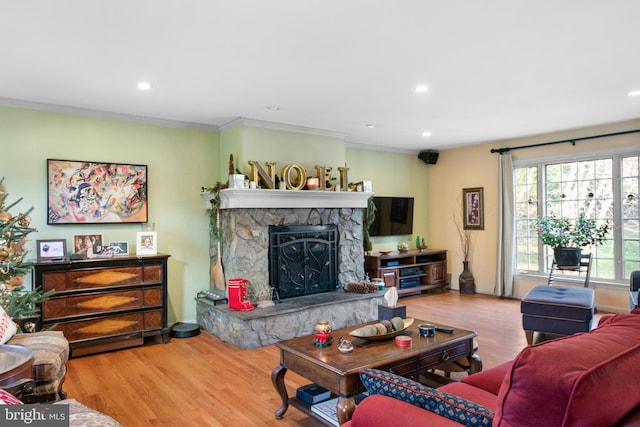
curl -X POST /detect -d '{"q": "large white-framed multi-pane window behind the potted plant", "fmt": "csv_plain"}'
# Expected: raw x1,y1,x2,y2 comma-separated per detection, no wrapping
514,154,640,282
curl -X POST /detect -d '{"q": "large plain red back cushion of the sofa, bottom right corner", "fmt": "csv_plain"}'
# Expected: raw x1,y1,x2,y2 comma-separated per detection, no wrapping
494,314,640,427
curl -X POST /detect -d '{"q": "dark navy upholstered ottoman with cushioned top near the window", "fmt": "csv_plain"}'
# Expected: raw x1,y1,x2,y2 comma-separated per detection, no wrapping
520,285,594,344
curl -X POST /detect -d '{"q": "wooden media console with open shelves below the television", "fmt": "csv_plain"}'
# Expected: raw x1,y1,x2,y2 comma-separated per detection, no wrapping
364,250,449,296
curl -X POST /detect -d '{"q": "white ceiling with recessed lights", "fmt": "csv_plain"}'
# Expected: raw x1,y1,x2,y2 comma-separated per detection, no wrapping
0,0,640,151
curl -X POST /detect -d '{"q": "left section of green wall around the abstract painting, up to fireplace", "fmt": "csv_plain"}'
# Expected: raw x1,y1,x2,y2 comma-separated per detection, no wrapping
0,107,220,323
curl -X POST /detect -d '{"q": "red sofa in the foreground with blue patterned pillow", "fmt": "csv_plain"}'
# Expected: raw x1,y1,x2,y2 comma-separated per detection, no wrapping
345,310,640,427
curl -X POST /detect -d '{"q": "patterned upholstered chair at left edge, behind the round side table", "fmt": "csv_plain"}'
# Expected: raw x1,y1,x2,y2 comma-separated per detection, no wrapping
7,331,69,403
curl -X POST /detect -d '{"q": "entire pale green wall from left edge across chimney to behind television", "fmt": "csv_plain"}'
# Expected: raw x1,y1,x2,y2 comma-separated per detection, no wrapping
0,107,429,323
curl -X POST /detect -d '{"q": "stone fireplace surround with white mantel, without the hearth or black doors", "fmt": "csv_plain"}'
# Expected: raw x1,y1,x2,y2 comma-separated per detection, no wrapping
212,189,372,298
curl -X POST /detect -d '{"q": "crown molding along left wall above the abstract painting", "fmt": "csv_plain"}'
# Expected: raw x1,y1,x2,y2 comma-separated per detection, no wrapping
0,97,220,132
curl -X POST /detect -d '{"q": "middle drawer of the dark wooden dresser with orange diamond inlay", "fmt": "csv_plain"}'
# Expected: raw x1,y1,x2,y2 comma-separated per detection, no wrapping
43,288,162,321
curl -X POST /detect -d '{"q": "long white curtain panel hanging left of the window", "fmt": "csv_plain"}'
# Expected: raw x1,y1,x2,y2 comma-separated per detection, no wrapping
495,153,515,297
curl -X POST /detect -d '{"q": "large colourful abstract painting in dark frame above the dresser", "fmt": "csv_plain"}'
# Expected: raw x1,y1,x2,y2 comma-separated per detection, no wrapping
47,159,148,225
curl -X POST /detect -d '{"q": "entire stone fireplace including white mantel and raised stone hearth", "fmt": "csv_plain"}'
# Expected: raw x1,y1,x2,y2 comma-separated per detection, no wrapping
196,189,382,349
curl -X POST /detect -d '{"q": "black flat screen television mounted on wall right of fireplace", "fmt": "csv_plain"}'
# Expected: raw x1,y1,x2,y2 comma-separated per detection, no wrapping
369,197,413,236
